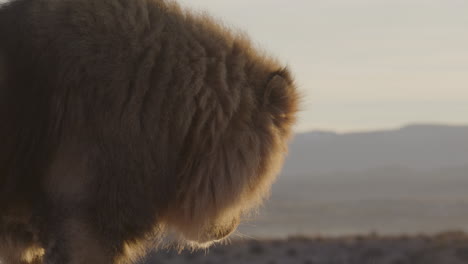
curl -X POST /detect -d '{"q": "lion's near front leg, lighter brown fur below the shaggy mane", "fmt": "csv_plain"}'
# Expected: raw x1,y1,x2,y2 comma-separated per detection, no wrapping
41,144,126,264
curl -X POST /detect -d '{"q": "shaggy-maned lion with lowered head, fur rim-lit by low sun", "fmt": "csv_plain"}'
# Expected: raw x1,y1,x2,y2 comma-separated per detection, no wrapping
0,0,300,264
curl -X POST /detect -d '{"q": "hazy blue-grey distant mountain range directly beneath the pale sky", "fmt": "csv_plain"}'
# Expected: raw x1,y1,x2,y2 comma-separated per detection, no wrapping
282,125,468,177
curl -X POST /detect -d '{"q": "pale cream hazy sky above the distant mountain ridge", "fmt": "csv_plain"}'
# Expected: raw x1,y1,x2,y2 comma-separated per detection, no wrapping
176,0,468,131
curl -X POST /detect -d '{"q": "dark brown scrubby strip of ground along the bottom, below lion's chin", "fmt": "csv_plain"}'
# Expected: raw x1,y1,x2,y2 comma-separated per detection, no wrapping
144,232,468,264
